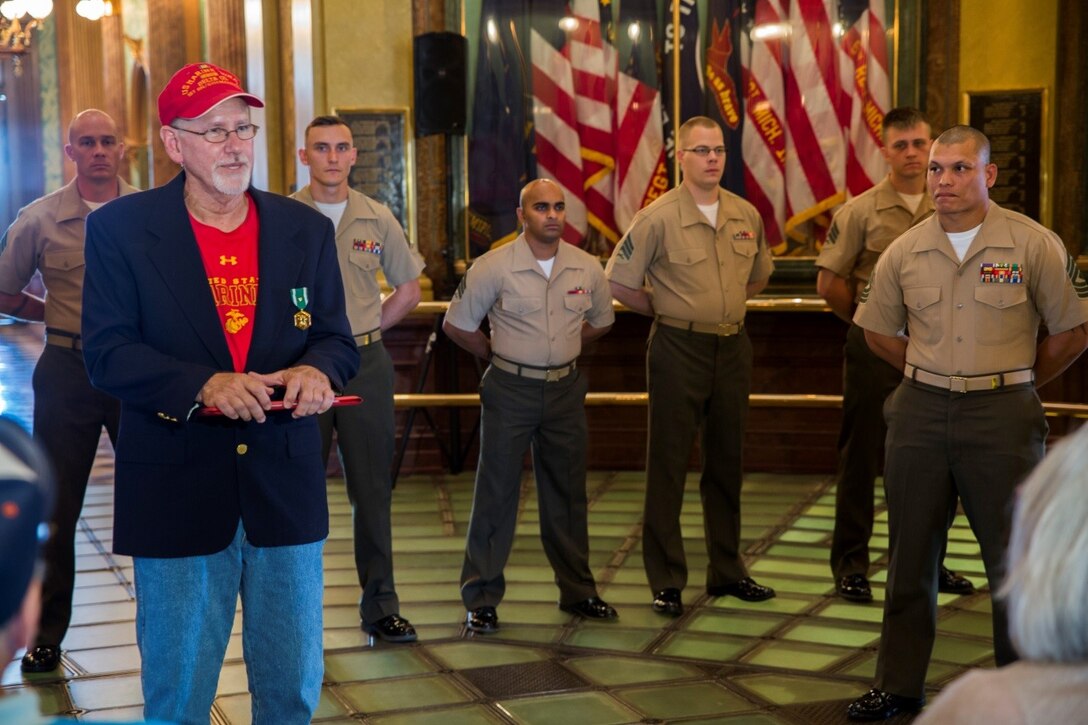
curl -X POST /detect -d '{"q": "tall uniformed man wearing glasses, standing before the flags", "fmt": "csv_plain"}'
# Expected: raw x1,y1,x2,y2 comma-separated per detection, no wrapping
605,116,775,616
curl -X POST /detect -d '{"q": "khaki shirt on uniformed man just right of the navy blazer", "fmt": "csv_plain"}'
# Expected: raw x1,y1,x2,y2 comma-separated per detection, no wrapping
290,184,423,335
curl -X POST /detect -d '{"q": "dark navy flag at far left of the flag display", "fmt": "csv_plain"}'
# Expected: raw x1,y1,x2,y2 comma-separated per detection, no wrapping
469,0,535,257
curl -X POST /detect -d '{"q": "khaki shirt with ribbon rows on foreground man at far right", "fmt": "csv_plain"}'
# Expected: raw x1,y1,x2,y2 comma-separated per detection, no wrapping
854,202,1088,376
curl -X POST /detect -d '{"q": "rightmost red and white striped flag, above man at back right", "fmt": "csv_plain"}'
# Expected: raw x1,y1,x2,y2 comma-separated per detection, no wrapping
842,0,891,196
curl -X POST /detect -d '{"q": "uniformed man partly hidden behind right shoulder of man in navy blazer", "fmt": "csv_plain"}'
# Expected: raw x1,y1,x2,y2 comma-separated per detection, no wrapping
292,115,423,642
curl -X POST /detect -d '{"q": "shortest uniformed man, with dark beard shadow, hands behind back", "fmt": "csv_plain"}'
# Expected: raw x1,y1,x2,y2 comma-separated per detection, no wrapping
443,179,616,632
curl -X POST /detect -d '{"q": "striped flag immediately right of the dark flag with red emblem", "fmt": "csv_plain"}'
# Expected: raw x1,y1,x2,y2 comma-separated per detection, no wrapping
741,0,789,254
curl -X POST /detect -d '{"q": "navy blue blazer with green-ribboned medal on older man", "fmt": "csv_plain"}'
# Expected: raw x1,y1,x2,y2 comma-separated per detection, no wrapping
84,172,359,557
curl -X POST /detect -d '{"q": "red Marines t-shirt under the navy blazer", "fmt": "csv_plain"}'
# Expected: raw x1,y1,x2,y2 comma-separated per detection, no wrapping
189,194,259,372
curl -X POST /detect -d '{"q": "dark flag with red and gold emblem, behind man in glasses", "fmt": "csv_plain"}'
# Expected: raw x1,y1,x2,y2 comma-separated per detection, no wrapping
706,0,744,196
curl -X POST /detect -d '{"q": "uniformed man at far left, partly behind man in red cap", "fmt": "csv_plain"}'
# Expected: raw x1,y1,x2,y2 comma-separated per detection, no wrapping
0,109,136,672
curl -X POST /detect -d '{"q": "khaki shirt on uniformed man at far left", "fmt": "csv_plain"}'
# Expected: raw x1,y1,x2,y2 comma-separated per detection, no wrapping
0,179,137,333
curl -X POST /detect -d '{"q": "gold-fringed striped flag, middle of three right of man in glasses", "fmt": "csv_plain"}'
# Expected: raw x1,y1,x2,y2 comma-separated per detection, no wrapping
786,0,846,241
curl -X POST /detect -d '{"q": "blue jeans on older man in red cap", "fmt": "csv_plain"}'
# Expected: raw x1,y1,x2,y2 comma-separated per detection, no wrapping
134,523,324,725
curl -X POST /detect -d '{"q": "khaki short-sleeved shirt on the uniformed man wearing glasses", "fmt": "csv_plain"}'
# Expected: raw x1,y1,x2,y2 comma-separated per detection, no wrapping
605,185,775,324
